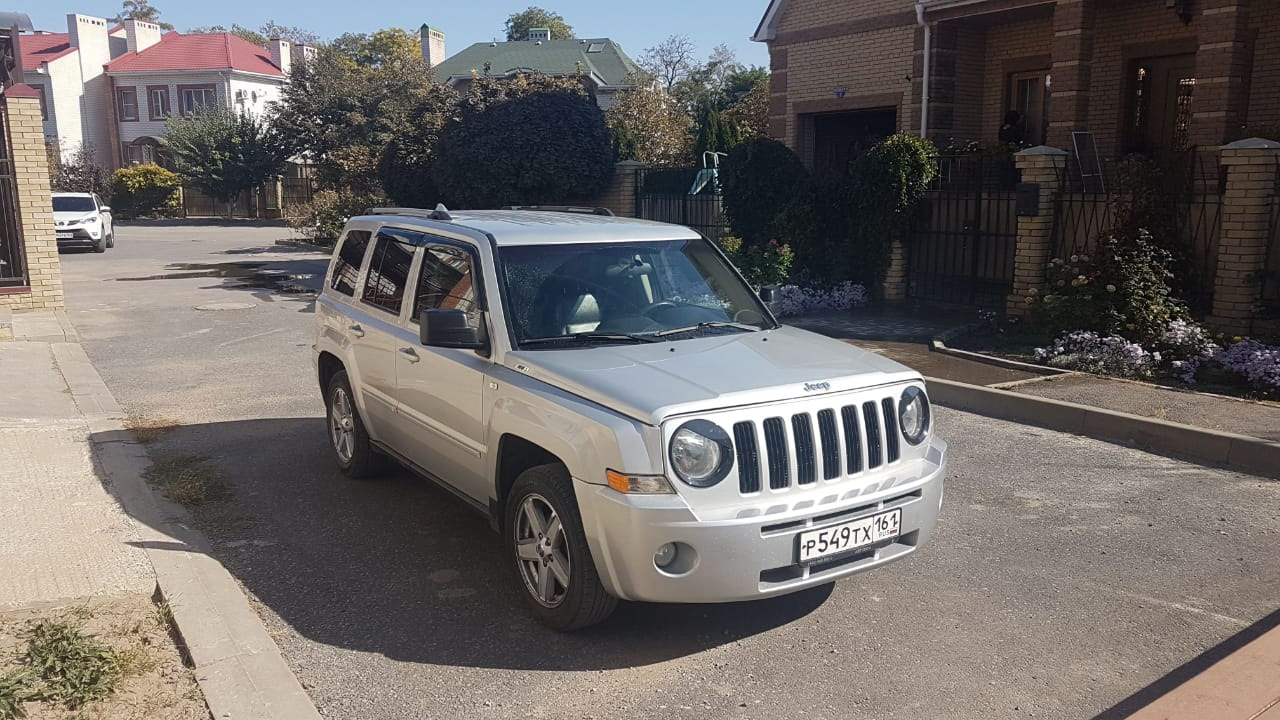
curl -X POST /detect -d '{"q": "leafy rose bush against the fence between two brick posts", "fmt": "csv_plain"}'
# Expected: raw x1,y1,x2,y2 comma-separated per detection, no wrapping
1028,231,1189,346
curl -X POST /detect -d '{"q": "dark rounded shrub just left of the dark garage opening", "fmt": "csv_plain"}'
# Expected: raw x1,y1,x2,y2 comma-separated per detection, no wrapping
719,138,809,249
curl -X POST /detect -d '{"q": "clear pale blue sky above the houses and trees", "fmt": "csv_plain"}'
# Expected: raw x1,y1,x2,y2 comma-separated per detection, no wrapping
27,0,769,67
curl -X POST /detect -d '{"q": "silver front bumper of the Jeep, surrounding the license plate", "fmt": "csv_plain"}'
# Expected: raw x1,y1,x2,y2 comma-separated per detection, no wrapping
573,439,946,602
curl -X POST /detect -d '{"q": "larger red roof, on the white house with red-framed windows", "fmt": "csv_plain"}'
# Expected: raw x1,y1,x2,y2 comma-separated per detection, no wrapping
106,32,284,77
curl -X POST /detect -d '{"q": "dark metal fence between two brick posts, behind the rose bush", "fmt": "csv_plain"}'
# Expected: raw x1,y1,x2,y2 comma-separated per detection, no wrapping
1053,152,1226,311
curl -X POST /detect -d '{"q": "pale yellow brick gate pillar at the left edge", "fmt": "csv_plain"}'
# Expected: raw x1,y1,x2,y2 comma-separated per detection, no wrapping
0,85,63,310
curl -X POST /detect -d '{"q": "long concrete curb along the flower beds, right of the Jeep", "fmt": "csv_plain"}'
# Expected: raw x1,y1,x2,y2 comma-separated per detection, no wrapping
925,378,1280,479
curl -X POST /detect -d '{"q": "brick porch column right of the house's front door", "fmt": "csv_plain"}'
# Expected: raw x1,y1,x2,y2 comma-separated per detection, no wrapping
1187,0,1252,147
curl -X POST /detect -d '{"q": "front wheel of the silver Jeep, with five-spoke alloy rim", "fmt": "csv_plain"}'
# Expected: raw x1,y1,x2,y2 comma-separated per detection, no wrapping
504,465,618,630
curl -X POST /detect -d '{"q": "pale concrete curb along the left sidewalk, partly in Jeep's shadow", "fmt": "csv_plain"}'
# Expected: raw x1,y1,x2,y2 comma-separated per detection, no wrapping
52,342,320,720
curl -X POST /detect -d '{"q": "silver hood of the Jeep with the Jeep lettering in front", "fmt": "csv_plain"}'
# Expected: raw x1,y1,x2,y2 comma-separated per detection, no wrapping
507,327,920,425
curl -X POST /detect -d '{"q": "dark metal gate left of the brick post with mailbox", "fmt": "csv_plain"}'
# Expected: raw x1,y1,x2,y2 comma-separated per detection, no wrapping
906,155,1019,306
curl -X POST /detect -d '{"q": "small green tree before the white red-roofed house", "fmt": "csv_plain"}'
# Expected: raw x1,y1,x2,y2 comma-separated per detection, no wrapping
165,108,289,218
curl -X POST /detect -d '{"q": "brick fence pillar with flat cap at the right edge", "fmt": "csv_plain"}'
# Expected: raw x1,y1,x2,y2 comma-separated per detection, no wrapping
1207,138,1280,334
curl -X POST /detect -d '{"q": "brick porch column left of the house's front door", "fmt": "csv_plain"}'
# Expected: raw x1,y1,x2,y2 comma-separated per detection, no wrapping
1047,0,1094,147
